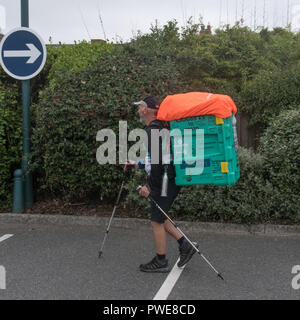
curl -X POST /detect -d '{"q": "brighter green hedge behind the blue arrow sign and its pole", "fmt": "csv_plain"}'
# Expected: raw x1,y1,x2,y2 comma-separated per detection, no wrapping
0,42,114,209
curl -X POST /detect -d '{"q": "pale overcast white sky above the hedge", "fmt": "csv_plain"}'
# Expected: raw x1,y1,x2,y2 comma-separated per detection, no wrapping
0,0,300,43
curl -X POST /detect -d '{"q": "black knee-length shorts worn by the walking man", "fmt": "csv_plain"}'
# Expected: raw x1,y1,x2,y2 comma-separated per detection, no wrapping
150,183,180,224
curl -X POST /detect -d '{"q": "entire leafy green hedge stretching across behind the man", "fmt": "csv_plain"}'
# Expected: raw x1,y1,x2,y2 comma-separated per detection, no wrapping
0,21,300,223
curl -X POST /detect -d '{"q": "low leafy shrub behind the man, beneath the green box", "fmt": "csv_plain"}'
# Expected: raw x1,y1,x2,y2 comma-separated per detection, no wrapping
125,148,273,223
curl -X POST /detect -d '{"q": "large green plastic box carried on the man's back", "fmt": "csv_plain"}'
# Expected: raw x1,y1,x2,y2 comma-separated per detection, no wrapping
170,115,240,186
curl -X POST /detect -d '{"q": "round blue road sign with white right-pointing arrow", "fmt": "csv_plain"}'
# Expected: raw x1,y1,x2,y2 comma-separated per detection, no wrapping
0,27,47,80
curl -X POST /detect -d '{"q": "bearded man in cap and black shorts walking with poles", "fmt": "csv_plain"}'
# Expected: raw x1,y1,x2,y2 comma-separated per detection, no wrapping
124,97,198,272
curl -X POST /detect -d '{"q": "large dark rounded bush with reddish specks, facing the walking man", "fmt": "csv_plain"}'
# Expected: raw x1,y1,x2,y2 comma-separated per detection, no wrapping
32,49,182,200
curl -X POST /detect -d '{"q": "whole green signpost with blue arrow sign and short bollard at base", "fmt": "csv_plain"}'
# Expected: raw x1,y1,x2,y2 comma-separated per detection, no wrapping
0,0,47,213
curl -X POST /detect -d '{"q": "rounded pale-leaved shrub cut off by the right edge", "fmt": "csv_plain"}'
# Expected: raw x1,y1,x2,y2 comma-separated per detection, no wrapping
260,107,300,221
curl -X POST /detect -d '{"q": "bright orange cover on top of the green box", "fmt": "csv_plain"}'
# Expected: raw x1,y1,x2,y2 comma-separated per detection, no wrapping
157,92,237,121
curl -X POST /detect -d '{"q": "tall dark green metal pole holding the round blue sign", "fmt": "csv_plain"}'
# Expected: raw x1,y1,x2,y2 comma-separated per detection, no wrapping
21,0,33,209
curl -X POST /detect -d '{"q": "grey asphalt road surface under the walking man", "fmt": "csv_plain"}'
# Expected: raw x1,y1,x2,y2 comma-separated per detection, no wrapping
0,223,300,300
